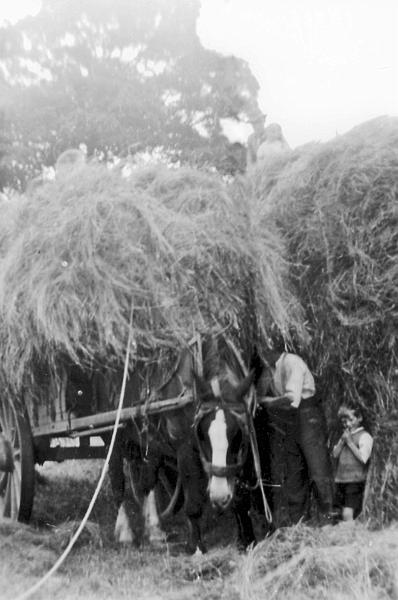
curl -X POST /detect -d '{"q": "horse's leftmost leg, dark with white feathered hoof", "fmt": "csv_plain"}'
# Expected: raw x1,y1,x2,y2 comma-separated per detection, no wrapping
104,433,134,544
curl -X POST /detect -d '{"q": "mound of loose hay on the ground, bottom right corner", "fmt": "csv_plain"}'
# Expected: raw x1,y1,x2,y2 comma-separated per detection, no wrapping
241,523,398,600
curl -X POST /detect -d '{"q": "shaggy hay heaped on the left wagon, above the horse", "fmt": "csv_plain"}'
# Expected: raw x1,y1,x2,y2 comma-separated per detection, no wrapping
0,165,302,386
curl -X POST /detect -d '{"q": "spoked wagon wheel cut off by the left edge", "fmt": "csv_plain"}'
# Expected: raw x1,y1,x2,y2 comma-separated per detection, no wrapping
0,398,35,521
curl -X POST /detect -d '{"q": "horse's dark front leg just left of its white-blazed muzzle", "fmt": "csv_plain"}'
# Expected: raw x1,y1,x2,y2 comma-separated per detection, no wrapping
177,444,207,554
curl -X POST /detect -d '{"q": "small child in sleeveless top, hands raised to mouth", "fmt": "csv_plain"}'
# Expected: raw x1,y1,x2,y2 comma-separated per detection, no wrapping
333,404,373,521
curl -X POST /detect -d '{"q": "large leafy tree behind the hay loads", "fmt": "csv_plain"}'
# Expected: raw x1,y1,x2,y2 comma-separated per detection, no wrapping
0,0,259,187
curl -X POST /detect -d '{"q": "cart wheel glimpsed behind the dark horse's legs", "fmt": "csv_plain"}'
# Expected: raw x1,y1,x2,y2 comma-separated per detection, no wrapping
129,459,184,519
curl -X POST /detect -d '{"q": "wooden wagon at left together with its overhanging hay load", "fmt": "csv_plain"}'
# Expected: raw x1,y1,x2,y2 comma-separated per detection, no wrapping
0,165,300,520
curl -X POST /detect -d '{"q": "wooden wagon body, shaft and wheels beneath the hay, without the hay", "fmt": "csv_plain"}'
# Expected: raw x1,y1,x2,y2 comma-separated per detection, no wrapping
0,346,196,521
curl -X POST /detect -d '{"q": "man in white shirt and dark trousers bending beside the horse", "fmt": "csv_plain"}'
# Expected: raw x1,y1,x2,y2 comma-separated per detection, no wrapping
255,340,333,527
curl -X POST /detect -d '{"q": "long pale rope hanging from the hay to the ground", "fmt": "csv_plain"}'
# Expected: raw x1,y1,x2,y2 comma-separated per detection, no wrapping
15,306,133,600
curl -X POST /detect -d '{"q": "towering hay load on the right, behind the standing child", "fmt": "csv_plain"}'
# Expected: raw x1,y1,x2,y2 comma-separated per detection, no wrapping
238,117,398,523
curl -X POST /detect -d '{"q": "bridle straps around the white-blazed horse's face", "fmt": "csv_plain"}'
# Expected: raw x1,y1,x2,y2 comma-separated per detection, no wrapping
193,397,250,478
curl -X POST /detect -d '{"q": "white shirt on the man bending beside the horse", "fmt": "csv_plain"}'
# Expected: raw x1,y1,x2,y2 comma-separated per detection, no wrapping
274,352,315,408
